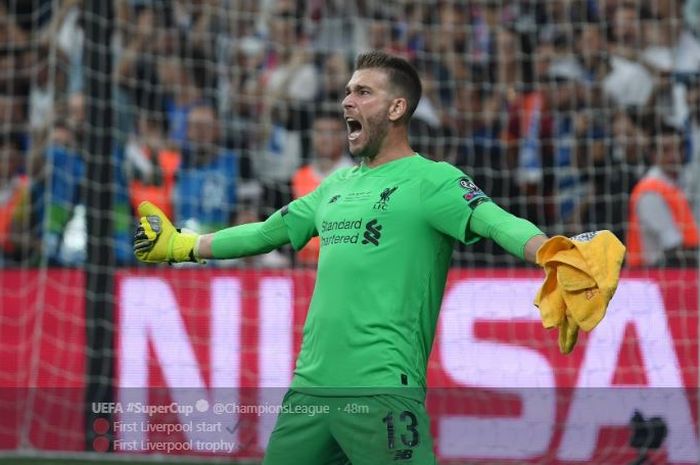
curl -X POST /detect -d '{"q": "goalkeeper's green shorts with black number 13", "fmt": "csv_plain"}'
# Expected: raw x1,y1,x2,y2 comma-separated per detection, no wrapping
263,390,437,465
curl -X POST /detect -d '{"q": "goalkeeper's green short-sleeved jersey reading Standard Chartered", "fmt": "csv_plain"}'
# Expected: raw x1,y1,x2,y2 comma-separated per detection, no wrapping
283,154,488,397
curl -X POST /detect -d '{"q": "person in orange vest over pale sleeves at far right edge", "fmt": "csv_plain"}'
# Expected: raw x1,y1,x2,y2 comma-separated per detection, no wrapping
627,125,700,266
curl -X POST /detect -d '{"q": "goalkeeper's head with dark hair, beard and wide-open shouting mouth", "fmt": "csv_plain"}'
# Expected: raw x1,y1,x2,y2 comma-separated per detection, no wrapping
343,52,421,160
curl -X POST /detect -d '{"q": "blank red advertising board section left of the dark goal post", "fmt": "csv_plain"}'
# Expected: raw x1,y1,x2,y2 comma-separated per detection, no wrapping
0,270,86,450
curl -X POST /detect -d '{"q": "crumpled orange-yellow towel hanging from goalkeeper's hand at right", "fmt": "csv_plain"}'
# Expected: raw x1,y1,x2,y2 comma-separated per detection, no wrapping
535,230,625,354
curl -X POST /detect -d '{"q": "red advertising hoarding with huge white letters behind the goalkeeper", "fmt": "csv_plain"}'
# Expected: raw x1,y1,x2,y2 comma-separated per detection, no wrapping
0,269,698,464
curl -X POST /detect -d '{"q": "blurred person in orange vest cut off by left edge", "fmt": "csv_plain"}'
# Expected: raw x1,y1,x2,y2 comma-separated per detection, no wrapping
0,133,33,265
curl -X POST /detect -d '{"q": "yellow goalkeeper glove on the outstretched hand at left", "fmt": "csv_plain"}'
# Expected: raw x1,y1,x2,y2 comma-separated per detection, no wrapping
134,202,199,263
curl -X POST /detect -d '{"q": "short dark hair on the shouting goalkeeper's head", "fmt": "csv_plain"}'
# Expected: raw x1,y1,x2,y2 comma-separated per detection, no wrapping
355,50,423,121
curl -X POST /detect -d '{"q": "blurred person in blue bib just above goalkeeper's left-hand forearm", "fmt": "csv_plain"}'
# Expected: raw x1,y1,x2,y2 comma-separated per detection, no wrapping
174,101,238,234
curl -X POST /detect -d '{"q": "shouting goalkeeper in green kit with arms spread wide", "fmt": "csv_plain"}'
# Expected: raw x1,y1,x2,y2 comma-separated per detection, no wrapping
134,52,616,465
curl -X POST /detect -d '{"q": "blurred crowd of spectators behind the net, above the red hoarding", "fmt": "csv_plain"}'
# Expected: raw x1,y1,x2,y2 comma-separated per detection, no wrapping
0,0,700,266
